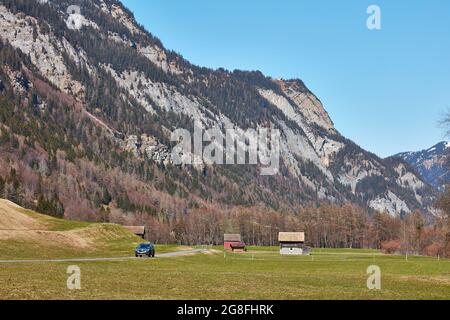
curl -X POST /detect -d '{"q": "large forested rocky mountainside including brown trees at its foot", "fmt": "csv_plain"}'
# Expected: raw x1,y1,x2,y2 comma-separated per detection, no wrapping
0,0,444,256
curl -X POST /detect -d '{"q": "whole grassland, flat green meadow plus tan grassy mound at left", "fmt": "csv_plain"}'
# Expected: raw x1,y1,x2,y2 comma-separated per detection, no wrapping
0,201,450,299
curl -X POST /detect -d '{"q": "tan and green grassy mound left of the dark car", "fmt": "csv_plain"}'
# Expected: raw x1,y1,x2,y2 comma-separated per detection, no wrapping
0,200,142,259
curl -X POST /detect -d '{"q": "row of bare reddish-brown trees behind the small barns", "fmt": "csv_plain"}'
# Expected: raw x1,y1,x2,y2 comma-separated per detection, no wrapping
137,202,450,257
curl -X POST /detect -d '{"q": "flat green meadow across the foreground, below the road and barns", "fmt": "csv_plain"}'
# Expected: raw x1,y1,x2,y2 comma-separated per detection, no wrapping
0,248,450,299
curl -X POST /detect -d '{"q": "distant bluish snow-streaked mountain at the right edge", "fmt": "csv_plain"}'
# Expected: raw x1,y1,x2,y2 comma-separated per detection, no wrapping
395,142,450,190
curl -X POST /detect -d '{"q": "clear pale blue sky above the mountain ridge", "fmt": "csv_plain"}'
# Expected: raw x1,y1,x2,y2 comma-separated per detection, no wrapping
123,0,450,157
